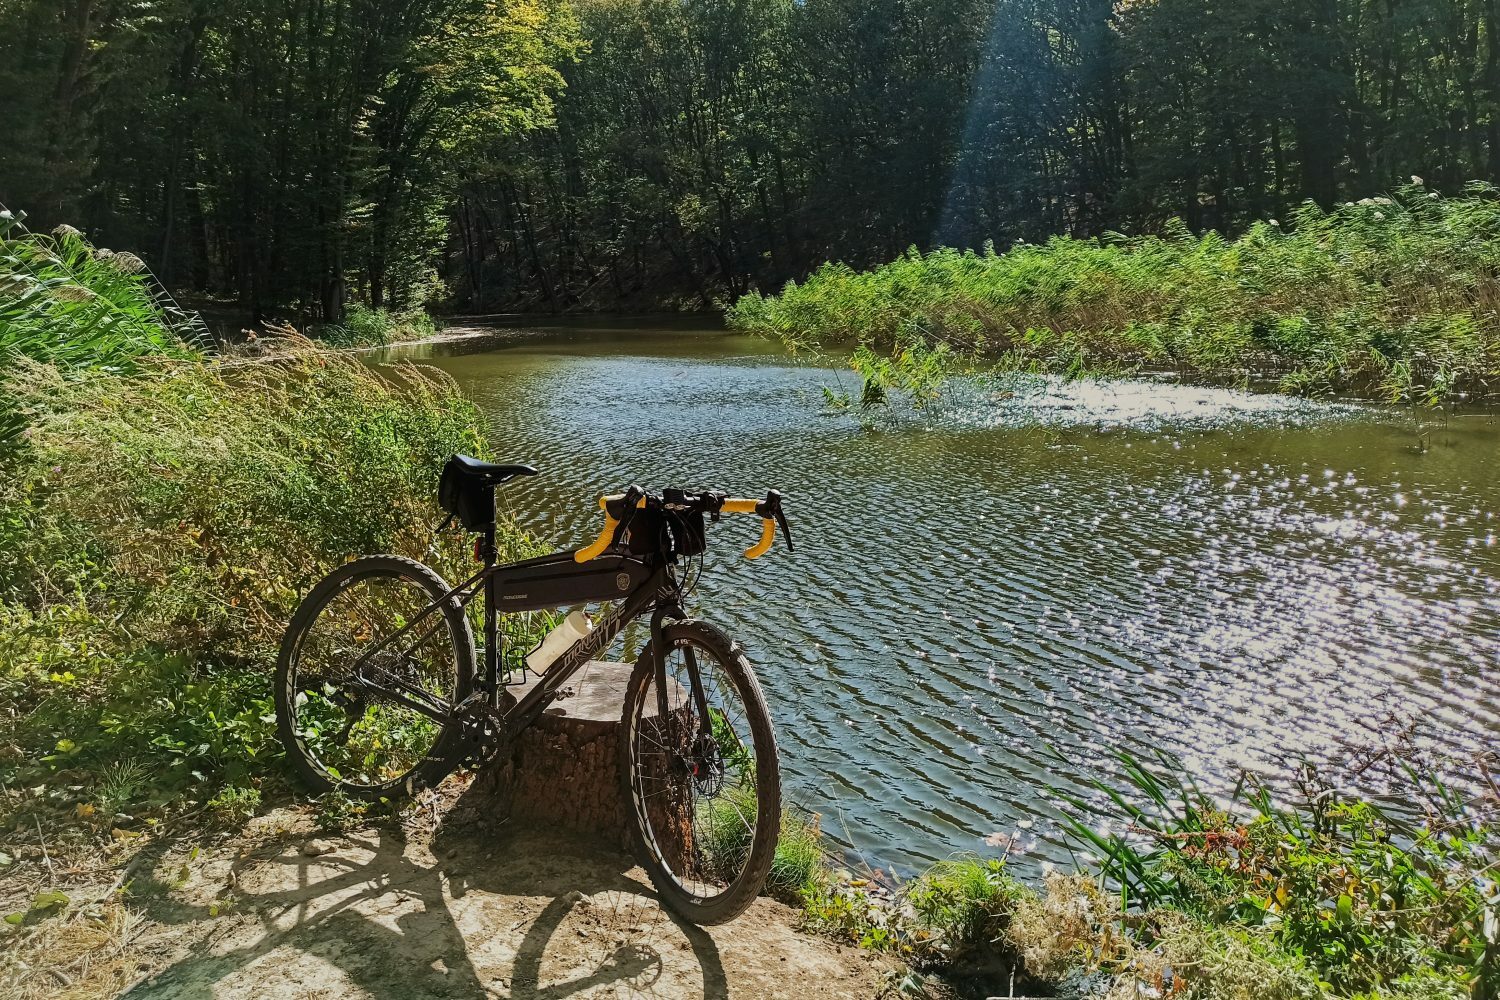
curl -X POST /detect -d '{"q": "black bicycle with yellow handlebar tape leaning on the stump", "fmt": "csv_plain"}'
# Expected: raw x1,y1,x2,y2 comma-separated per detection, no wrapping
275,456,792,924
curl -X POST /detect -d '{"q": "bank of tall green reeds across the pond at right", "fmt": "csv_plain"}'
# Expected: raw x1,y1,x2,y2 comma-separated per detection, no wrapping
729,184,1500,403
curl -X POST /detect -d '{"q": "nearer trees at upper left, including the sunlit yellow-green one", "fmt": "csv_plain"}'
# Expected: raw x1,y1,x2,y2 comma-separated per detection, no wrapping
0,0,576,322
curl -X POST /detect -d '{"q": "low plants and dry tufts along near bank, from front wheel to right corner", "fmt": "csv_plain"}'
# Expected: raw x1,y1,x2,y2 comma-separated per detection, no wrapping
803,747,1500,1000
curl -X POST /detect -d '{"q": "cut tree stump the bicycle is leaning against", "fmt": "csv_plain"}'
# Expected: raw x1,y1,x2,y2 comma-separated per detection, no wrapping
462,661,695,871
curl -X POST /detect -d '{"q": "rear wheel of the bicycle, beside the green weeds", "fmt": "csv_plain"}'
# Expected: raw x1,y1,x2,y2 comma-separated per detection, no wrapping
276,556,474,799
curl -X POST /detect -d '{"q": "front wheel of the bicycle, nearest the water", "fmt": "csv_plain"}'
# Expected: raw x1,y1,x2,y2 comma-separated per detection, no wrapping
621,621,782,924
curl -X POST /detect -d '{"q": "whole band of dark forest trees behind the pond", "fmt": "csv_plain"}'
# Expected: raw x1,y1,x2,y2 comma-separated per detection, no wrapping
0,0,1500,322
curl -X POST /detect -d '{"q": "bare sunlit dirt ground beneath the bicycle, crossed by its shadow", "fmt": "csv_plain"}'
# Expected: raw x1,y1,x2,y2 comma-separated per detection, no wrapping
108,814,890,1000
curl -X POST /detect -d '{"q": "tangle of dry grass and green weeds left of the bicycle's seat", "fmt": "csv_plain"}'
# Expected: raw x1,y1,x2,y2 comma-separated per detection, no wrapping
0,335,504,813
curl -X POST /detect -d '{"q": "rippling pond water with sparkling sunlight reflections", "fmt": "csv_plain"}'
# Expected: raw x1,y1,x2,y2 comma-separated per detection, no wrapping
395,321,1500,870
